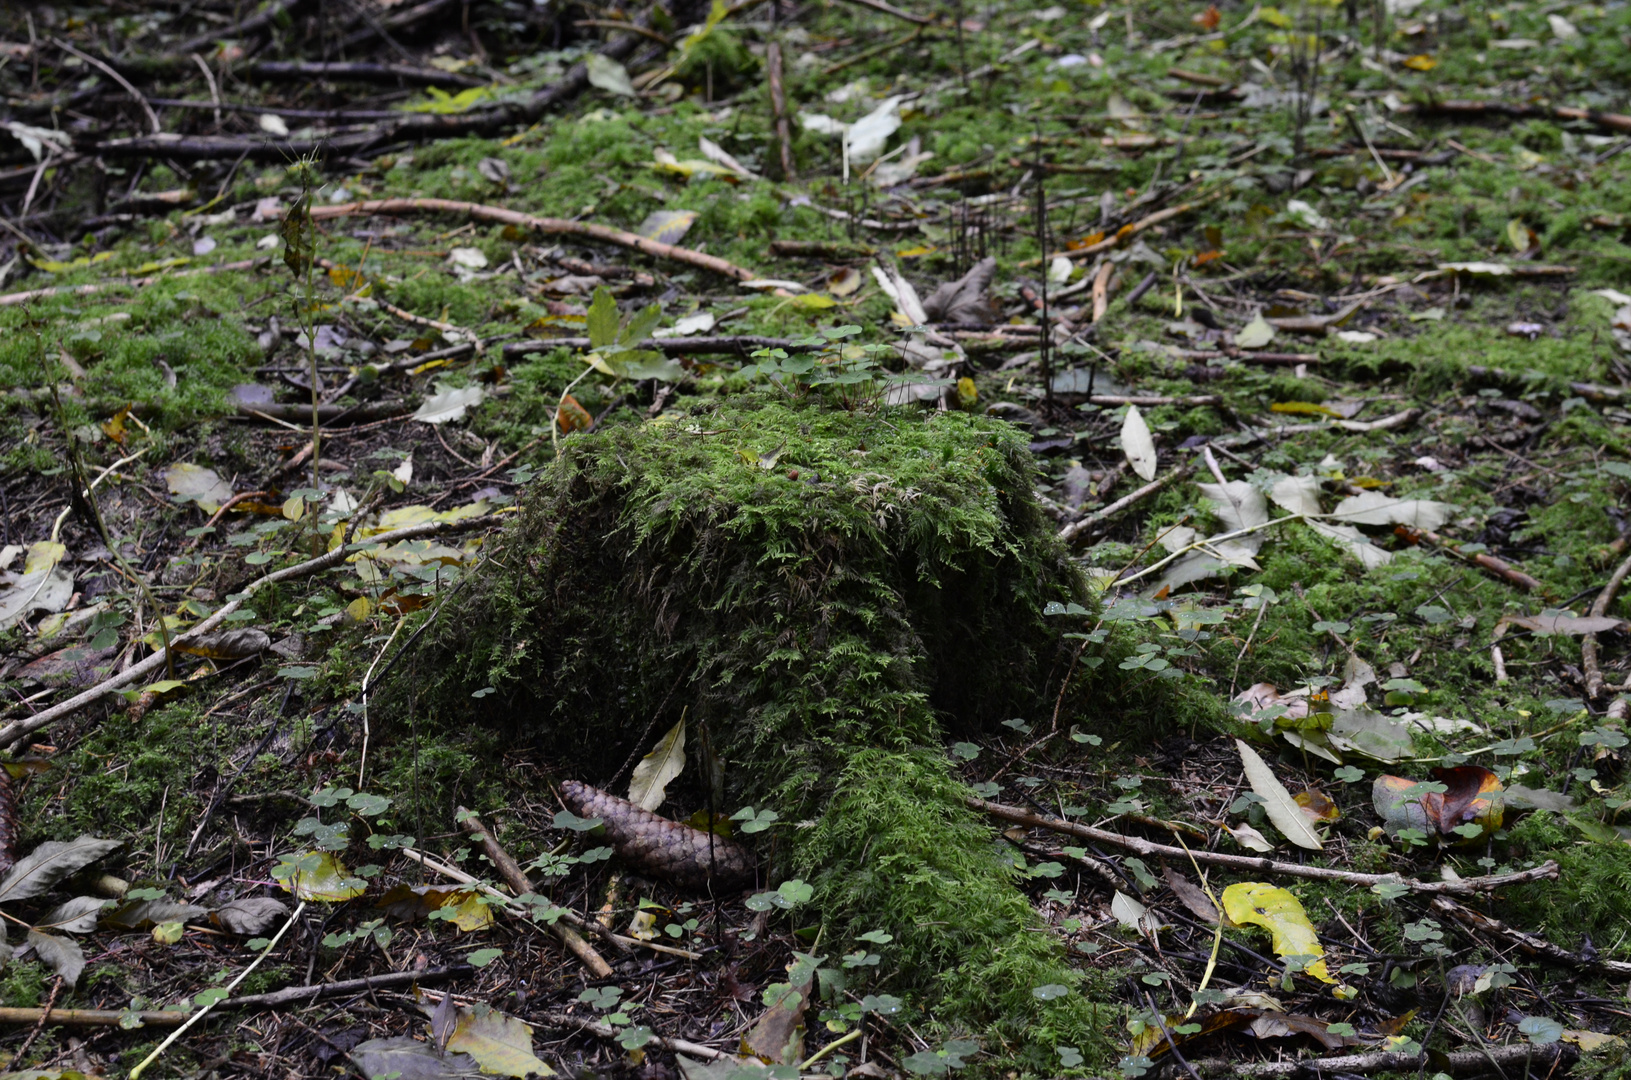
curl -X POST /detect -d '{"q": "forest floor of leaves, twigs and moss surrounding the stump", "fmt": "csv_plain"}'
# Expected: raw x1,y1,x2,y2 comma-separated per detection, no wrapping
0,0,1631,1080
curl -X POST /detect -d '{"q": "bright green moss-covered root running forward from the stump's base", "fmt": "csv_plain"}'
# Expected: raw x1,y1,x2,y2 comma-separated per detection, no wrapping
796,749,1111,1075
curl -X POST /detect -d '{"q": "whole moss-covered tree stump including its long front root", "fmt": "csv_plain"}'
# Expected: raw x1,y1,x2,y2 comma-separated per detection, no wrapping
418,401,1099,1069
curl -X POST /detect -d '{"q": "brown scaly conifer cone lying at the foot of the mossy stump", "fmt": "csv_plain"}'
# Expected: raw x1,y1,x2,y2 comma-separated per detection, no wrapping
561,780,754,892
